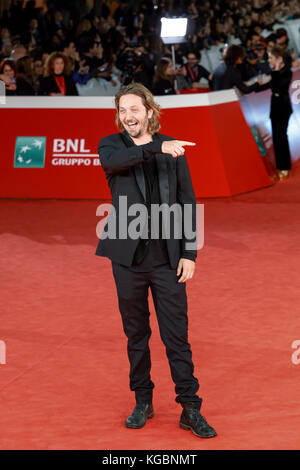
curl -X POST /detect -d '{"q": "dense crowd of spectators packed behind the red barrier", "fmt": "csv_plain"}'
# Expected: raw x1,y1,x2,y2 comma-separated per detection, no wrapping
0,0,300,96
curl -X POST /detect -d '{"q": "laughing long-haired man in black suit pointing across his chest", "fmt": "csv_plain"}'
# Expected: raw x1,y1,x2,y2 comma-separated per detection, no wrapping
96,83,216,437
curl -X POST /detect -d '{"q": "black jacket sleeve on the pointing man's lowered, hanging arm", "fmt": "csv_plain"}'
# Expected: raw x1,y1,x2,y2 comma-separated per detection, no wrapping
176,155,197,261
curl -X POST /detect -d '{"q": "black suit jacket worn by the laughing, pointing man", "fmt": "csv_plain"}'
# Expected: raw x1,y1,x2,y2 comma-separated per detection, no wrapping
96,131,197,269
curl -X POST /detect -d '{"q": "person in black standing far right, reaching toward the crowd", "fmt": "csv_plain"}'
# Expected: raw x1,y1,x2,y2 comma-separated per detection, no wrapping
255,45,293,181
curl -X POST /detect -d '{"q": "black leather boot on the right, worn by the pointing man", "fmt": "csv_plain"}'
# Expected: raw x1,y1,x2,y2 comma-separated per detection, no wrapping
179,402,217,438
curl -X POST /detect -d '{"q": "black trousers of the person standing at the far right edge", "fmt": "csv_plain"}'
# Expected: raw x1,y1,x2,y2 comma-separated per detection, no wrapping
271,116,291,170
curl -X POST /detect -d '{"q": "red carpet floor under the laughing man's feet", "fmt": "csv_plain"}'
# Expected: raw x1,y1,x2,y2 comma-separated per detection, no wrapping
0,167,300,450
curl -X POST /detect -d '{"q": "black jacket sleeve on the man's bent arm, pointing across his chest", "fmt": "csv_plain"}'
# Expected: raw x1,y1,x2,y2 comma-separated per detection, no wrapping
98,137,161,175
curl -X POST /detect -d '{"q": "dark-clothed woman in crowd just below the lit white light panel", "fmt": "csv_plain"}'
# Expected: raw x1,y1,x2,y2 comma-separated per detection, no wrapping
153,57,179,95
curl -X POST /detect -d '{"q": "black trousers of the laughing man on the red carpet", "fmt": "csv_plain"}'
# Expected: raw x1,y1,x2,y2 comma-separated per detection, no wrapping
112,262,202,403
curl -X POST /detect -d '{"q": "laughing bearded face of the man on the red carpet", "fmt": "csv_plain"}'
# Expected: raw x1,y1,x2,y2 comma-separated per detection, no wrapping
119,94,153,138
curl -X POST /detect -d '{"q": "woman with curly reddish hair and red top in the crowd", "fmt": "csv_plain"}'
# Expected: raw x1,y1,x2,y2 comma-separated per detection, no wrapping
39,52,78,96
